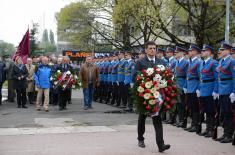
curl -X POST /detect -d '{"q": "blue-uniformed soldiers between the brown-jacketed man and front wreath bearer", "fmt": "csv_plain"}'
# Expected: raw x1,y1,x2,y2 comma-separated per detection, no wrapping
94,52,135,111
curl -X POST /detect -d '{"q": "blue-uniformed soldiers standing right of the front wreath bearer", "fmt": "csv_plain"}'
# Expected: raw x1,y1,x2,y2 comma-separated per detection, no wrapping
162,43,235,143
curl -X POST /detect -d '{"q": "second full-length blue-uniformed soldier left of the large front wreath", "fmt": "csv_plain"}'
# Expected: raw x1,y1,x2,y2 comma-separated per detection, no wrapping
116,52,126,106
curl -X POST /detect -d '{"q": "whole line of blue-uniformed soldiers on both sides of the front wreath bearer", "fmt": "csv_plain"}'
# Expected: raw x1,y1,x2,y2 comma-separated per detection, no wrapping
94,43,235,143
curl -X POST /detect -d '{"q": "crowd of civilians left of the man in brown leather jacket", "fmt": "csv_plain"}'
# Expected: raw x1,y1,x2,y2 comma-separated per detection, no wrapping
0,56,79,112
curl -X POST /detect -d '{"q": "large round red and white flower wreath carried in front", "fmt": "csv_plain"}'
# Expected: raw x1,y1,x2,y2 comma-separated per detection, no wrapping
132,65,177,115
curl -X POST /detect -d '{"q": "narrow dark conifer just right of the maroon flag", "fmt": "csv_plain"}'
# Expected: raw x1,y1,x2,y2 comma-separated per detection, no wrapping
29,23,39,56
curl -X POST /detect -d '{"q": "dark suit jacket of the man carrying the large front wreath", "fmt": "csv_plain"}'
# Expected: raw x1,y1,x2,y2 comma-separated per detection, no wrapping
133,56,167,81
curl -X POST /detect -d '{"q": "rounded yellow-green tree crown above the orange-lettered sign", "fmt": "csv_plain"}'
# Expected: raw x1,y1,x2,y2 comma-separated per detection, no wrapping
57,2,94,50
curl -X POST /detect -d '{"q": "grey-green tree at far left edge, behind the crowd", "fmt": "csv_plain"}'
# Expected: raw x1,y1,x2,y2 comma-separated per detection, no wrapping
0,41,16,57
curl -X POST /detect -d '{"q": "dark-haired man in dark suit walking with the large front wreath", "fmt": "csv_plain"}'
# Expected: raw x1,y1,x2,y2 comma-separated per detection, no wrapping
133,41,170,152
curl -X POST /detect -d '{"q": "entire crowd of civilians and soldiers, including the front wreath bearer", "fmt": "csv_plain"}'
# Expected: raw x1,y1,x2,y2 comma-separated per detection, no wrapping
0,42,235,152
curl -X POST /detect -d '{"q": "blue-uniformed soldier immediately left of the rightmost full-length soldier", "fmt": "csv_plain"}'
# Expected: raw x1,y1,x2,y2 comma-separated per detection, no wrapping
197,45,219,137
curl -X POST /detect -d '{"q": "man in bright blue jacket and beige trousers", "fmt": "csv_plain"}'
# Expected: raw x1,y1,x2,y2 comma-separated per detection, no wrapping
34,57,51,112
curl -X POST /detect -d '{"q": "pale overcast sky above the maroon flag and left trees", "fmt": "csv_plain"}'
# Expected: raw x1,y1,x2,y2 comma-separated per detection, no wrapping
0,0,74,46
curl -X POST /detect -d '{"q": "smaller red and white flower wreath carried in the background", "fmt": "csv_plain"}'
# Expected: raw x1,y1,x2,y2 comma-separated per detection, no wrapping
51,70,81,91
